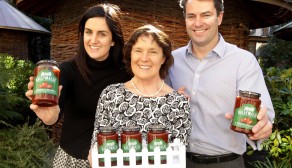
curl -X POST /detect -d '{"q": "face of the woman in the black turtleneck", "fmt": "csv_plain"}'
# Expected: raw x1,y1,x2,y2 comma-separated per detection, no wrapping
84,17,114,61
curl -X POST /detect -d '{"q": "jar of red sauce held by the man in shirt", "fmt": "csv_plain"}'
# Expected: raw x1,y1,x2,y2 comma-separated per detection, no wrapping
230,90,261,134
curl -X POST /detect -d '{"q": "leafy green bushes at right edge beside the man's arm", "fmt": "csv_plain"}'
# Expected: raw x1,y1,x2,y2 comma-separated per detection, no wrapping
246,67,292,166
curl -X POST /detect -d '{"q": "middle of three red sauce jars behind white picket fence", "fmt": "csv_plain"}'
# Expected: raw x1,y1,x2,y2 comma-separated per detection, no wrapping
121,126,142,165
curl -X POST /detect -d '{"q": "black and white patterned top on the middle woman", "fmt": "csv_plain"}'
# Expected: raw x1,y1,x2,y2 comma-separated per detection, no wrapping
91,83,191,147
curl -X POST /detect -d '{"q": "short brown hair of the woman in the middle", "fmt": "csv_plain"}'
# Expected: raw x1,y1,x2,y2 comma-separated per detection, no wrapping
124,25,173,79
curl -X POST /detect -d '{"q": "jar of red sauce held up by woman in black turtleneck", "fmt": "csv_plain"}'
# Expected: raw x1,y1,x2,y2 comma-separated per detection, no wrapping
32,60,60,107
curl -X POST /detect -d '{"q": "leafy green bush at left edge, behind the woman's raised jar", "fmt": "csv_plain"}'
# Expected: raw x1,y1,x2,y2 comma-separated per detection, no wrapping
0,53,34,126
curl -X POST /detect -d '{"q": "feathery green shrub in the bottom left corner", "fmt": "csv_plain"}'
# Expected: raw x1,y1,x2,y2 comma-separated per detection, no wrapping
0,120,56,168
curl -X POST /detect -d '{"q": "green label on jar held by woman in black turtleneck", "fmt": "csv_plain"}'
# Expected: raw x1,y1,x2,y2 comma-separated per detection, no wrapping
33,69,59,96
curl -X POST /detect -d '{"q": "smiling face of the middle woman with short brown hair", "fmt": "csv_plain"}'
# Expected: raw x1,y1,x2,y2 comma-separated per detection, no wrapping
131,35,165,80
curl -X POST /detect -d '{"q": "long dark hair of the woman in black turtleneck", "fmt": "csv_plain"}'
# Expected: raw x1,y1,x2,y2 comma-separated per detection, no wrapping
74,3,124,84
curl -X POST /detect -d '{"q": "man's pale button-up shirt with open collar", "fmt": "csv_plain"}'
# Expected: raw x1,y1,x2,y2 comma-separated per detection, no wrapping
166,35,275,155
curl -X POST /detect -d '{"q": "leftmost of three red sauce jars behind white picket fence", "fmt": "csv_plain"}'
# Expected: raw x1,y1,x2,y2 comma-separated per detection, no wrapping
96,127,119,166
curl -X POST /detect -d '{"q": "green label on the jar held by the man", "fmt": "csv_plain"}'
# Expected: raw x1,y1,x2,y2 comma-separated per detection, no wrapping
232,104,258,130
